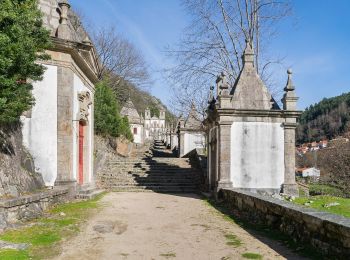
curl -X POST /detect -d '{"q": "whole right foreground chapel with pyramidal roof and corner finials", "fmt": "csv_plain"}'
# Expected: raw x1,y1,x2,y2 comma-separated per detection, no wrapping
206,40,300,195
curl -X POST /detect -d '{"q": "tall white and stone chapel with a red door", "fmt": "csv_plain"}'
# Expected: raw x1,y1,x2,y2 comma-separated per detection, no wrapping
22,0,99,186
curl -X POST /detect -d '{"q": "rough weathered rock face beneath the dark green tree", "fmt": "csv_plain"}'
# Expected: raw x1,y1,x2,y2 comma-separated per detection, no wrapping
0,126,44,197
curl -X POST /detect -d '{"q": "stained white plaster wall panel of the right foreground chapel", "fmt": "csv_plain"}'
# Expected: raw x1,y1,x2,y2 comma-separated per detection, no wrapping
231,122,284,189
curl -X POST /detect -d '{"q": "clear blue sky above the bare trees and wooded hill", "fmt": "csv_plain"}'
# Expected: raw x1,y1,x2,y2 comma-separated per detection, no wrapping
70,0,350,109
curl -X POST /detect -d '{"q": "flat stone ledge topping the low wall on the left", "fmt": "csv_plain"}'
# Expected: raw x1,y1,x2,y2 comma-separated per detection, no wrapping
0,188,68,208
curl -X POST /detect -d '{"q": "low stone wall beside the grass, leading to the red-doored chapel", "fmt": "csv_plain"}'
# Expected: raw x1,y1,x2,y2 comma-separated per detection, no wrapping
0,188,68,232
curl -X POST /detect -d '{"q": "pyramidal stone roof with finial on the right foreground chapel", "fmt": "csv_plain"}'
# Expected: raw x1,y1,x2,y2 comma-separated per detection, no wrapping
231,42,279,110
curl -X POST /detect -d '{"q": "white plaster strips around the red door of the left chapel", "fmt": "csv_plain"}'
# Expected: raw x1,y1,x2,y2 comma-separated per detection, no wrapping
72,74,94,182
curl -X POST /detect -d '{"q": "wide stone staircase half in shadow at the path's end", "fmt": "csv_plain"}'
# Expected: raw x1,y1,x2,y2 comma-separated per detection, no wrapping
98,141,200,193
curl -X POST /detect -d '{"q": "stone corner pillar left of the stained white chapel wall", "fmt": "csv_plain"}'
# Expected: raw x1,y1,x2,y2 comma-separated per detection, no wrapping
217,122,232,191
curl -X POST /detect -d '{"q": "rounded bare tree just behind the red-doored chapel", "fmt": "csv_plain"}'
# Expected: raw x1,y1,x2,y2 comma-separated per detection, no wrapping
93,27,150,88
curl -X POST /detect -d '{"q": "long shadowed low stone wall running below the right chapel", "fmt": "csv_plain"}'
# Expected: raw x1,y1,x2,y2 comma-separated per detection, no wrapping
220,189,350,259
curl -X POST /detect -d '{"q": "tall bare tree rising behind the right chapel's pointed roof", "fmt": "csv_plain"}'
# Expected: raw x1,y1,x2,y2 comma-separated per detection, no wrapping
166,0,291,118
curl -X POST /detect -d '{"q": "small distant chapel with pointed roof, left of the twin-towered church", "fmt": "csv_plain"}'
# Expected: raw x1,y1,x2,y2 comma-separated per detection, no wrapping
120,98,145,144
